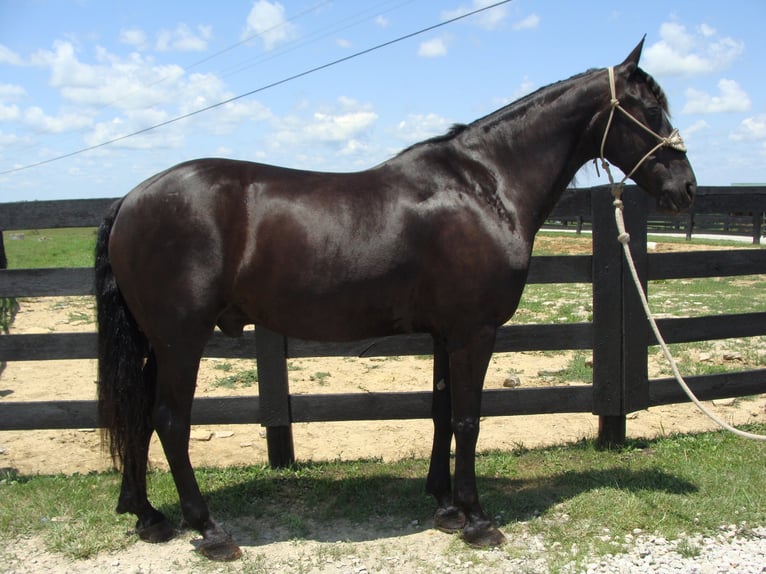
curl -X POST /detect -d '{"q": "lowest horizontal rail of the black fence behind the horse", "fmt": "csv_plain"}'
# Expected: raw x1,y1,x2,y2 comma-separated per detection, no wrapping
0,369,766,430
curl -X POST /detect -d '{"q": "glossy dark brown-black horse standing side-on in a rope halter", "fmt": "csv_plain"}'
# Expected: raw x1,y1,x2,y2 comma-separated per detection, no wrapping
96,41,696,560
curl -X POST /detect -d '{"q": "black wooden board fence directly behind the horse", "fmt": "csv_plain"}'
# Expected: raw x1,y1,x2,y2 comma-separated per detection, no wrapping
0,187,766,466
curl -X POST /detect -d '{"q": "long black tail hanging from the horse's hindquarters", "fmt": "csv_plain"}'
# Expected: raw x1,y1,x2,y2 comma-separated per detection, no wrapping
95,201,156,469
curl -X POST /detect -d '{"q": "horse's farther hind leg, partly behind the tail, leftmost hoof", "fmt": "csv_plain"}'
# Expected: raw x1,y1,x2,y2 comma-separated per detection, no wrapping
117,354,175,542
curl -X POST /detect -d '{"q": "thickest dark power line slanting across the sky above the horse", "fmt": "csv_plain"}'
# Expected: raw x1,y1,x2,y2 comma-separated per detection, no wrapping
0,0,512,175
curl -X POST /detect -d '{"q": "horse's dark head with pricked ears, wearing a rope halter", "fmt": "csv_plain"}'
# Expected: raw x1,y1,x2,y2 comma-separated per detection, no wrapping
599,40,697,212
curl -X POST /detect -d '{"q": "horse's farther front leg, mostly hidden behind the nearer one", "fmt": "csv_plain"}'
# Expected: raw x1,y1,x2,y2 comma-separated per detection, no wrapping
426,338,465,533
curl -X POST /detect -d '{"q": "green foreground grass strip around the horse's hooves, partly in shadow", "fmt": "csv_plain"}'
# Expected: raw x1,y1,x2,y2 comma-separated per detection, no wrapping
0,425,766,571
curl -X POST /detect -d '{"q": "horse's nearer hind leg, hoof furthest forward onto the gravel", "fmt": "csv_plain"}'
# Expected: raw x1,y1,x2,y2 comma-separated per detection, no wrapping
154,343,242,560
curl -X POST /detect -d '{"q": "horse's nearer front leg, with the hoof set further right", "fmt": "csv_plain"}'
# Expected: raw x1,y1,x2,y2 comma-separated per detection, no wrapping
449,327,505,546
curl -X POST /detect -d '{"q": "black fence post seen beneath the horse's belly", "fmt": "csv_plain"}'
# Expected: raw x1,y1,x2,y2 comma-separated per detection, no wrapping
255,327,295,468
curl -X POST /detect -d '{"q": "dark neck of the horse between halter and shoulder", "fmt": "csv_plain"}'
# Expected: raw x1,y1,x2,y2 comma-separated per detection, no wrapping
475,74,608,232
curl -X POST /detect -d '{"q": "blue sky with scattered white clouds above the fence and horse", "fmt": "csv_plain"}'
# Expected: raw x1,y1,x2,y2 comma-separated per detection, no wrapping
0,0,766,201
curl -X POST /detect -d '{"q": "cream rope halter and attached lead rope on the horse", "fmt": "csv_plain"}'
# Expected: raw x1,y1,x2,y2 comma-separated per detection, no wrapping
601,68,766,441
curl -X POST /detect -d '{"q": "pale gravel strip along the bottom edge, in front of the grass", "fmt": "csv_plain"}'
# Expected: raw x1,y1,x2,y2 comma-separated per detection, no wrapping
0,524,766,574
